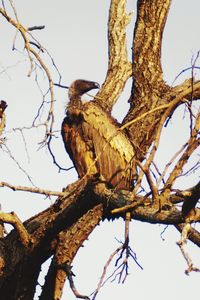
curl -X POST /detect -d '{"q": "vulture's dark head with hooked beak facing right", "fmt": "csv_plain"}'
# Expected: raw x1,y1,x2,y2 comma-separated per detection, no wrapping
69,79,100,99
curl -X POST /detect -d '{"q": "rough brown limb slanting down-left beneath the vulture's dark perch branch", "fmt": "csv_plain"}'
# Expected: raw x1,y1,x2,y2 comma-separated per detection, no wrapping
40,205,103,300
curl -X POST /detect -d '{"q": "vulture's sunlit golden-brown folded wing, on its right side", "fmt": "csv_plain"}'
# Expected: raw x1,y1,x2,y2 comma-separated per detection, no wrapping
81,102,135,189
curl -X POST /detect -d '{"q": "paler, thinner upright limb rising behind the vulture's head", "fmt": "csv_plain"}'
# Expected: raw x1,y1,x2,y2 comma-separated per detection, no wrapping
96,0,132,112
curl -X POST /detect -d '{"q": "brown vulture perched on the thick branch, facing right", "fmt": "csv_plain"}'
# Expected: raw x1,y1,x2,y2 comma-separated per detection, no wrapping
61,79,135,190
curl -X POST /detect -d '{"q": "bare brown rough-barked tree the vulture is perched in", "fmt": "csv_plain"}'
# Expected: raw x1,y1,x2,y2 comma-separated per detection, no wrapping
0,0,200,299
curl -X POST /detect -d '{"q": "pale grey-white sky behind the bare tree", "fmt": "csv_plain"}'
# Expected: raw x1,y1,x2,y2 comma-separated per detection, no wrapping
0,0,200,300
